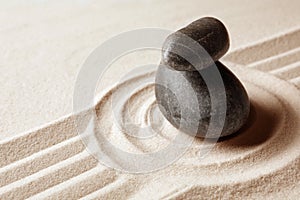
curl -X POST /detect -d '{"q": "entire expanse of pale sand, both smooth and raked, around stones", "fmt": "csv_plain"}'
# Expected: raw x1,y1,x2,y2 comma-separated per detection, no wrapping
0,1,300,199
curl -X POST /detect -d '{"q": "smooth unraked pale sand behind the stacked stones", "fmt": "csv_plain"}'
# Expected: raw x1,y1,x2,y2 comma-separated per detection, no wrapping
0,0,300,138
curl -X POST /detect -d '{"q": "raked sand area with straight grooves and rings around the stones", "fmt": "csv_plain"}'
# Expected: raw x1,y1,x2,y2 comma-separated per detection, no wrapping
0,32,300,199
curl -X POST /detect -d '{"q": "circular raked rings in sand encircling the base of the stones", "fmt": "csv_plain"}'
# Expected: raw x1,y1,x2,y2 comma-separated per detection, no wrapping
92,66,300,184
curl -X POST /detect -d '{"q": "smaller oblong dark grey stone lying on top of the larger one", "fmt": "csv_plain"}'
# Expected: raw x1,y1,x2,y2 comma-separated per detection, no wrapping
161,17,229,71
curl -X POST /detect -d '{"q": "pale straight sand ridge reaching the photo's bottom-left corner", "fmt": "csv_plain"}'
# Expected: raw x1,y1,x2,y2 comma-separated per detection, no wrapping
0,151,98,199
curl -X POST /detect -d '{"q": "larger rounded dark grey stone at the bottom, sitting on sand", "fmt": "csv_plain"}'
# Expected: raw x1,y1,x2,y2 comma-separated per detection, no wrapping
155,62,250,138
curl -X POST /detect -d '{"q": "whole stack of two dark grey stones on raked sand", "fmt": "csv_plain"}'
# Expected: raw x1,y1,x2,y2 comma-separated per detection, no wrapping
155,17,250,138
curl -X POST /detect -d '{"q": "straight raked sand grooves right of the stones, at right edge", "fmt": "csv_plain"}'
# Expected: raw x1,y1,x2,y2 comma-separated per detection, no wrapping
225,28,300,87
